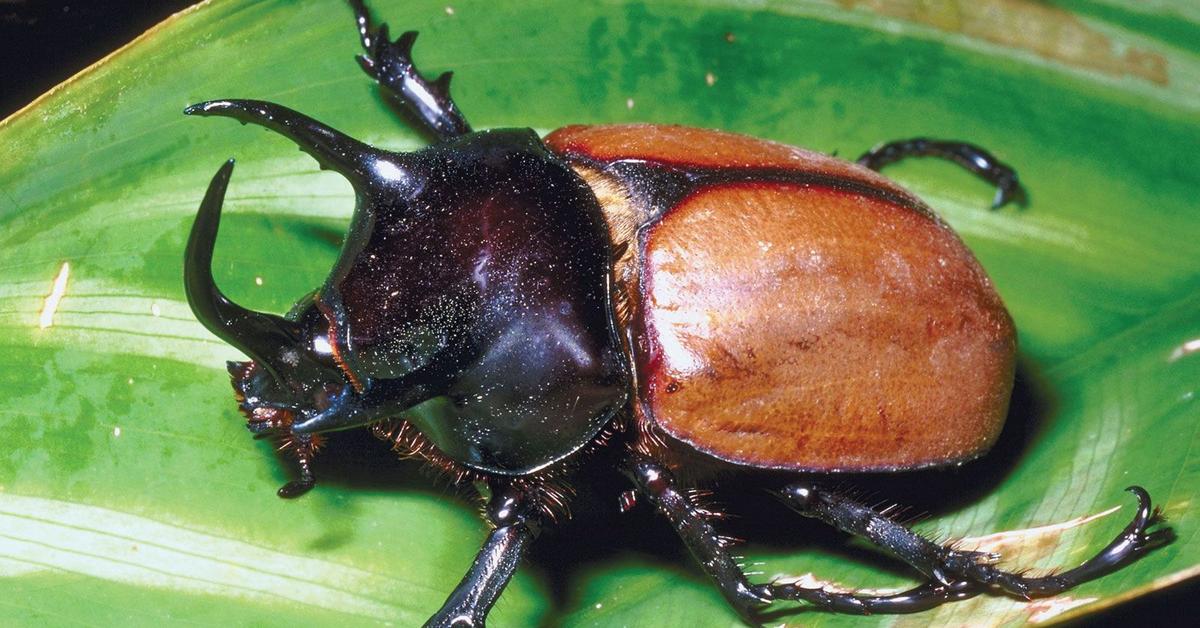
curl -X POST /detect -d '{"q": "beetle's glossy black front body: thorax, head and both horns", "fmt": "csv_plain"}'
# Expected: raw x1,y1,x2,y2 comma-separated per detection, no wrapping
187,101,629,476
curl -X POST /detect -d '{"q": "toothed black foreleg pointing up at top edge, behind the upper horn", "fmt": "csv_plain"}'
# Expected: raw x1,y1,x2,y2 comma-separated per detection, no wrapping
350,0,470,139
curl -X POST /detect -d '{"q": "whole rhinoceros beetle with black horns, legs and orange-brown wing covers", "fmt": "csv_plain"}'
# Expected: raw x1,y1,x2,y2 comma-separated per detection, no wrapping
185,0,1169,626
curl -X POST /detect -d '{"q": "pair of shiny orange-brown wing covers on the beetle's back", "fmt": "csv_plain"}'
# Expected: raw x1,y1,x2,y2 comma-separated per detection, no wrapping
547,126,1015,471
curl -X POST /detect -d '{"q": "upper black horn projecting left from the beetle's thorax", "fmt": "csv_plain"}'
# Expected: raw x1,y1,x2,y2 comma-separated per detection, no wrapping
184,100,397,187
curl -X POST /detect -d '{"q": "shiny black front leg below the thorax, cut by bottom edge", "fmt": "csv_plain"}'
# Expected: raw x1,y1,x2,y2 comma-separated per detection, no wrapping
425,486,538,628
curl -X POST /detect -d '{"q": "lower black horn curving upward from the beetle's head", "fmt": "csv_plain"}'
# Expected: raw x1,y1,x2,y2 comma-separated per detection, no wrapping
184,160,298,379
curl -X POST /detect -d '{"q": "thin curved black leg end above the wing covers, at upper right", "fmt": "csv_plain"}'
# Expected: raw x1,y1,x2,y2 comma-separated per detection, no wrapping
857,137,1027,209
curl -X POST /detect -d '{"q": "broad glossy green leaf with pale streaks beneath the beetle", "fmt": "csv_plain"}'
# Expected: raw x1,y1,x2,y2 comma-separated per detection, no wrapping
0,0,1200,627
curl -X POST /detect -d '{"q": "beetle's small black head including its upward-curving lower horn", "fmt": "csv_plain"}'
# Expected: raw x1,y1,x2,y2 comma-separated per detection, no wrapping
184,160,348,431
